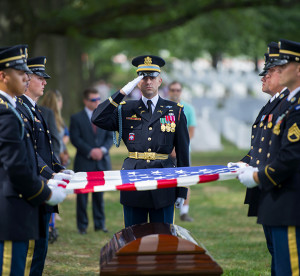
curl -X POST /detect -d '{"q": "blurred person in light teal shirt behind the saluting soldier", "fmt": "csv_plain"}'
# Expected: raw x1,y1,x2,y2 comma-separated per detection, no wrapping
168,81,197,221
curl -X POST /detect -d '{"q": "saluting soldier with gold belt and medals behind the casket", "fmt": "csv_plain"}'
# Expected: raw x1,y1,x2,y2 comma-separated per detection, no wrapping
92,55,189,227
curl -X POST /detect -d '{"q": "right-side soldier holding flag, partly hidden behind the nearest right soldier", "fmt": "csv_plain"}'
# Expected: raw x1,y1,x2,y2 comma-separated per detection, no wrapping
229,42,289,275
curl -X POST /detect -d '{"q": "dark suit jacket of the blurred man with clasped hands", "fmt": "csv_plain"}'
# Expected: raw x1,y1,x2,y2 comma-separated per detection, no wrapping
70,110,113,172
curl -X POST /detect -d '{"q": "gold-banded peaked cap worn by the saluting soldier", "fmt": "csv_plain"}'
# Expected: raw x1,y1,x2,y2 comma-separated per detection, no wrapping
132,55,165,77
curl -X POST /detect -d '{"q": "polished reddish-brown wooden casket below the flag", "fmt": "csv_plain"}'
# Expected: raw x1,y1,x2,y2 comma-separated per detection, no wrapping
100,223,223,276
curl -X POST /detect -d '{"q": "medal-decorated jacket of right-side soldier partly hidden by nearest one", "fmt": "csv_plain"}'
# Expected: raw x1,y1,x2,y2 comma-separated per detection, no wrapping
242,89,289,216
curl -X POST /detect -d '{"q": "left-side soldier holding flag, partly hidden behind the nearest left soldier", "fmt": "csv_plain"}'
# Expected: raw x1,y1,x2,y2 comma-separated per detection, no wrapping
17,56,73,275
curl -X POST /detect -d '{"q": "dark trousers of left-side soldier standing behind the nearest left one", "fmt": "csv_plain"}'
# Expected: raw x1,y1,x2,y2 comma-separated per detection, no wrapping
30,213,51,276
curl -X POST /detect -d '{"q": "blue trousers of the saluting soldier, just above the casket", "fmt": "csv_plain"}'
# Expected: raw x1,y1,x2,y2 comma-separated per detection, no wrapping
123,204,174,227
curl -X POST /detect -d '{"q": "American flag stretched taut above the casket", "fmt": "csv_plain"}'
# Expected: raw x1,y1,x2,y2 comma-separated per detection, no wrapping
66,165,237,194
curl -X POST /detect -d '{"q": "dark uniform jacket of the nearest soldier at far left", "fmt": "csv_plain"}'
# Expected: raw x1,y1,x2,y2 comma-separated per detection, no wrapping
0,95,51,241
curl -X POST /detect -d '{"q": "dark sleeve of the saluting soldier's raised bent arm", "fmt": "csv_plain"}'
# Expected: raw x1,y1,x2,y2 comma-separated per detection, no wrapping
92,91,125,131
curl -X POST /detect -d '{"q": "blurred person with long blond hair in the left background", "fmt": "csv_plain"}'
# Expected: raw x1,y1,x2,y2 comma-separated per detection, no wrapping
41,90,70,166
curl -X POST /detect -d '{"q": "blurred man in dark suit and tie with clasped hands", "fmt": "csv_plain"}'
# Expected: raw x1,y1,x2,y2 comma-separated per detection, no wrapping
70,88,113,234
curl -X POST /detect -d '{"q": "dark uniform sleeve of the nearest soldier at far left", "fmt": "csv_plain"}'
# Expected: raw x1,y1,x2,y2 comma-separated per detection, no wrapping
0,110,51,206
